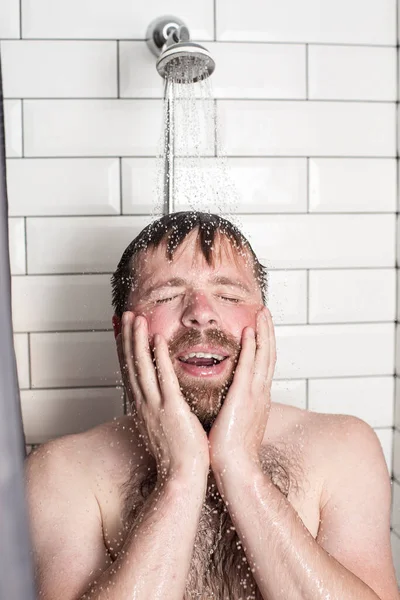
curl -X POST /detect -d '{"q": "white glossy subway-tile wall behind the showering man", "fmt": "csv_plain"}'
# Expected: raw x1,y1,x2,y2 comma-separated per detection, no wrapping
0,0,400,579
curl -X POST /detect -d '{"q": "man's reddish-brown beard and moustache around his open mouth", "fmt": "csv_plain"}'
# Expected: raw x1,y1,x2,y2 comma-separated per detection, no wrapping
168,329,241,434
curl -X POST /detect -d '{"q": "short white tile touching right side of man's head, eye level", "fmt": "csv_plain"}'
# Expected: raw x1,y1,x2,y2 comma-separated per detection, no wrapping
267,271,307,325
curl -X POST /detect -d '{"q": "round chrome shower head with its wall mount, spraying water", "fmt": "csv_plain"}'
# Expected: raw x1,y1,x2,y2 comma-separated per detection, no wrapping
146,16,215,83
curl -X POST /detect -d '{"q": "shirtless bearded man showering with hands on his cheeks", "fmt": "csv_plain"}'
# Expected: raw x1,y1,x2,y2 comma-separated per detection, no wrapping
26,213,399,600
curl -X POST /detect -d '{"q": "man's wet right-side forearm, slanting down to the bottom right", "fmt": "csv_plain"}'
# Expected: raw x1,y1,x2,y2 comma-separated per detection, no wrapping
216,463,379,600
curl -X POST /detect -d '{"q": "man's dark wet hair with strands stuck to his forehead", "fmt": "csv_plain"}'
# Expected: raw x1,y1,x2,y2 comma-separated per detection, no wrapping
111,211,268,318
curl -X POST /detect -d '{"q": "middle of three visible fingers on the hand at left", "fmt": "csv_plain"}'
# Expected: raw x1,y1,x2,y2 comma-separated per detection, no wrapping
131,316,161,403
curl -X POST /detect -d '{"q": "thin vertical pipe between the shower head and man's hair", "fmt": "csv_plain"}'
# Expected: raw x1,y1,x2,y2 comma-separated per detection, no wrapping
164,78,175,215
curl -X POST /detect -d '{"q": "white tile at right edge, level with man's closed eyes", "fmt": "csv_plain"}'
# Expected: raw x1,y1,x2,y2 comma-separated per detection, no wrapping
309,269,396,323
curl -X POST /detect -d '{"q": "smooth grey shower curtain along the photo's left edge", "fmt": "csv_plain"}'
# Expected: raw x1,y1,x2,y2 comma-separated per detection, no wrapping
0,50,36,600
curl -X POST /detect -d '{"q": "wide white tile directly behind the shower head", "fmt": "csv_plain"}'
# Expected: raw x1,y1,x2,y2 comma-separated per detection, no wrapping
120,42,306,99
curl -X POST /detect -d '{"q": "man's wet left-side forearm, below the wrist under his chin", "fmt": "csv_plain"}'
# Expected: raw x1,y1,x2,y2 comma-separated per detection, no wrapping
82,476,206,600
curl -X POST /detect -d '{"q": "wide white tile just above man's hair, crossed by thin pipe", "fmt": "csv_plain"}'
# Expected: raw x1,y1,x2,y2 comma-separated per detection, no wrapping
122,157,307,214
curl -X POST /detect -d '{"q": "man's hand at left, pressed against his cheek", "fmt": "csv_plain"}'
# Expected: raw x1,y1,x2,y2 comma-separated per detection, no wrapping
117,311,210,478
